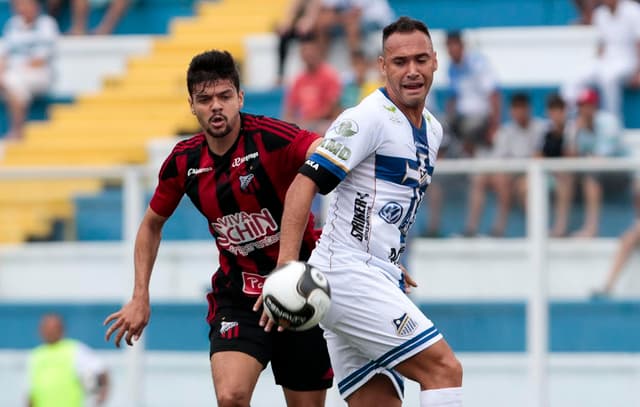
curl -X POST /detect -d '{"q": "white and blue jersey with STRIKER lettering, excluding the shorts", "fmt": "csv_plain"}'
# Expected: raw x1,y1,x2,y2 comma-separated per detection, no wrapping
300,88,442,283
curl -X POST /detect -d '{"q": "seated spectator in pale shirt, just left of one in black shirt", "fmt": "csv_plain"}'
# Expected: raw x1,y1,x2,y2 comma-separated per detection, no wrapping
464,93,545,237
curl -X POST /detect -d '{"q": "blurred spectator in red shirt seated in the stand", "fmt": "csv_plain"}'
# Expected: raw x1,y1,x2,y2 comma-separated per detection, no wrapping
283,34,342,134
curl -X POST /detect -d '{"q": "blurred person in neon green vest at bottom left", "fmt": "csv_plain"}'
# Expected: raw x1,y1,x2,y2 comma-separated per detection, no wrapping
27,314,109,407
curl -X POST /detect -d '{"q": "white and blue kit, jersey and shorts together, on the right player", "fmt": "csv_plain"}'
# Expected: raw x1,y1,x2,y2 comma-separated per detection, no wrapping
300,89,442,399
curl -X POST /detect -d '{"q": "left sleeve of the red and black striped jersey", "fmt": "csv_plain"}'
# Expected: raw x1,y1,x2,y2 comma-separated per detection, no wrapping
149,149,185,218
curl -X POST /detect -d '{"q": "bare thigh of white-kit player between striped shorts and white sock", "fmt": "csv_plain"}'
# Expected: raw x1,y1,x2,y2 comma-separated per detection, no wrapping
395,339,462,390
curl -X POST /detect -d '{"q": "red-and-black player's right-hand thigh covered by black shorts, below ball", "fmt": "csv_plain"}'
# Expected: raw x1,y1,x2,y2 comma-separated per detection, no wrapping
271,326,333,396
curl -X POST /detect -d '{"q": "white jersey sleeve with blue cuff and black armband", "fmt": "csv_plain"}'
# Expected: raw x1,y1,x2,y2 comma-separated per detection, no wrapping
300,104,382,194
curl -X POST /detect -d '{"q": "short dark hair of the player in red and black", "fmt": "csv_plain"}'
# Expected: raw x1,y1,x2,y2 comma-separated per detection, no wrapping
187,50,240,95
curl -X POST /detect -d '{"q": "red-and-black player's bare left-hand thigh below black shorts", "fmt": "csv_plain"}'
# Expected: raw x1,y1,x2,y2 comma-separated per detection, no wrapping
211,351,263,405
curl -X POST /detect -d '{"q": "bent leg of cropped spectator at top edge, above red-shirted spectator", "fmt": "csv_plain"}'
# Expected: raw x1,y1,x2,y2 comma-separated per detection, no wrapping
276,0,321,85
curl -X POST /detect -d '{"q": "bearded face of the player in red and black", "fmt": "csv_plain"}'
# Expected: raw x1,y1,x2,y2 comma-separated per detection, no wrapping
189,79,244,138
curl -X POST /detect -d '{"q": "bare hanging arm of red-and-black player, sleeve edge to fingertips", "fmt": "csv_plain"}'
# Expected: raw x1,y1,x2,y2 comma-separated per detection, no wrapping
104,208,167,347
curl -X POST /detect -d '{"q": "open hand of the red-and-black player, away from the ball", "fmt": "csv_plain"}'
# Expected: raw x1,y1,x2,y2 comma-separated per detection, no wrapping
103,298,151,348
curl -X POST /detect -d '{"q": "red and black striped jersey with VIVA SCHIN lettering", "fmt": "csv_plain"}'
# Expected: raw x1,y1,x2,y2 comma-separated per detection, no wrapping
150,113,319,319
